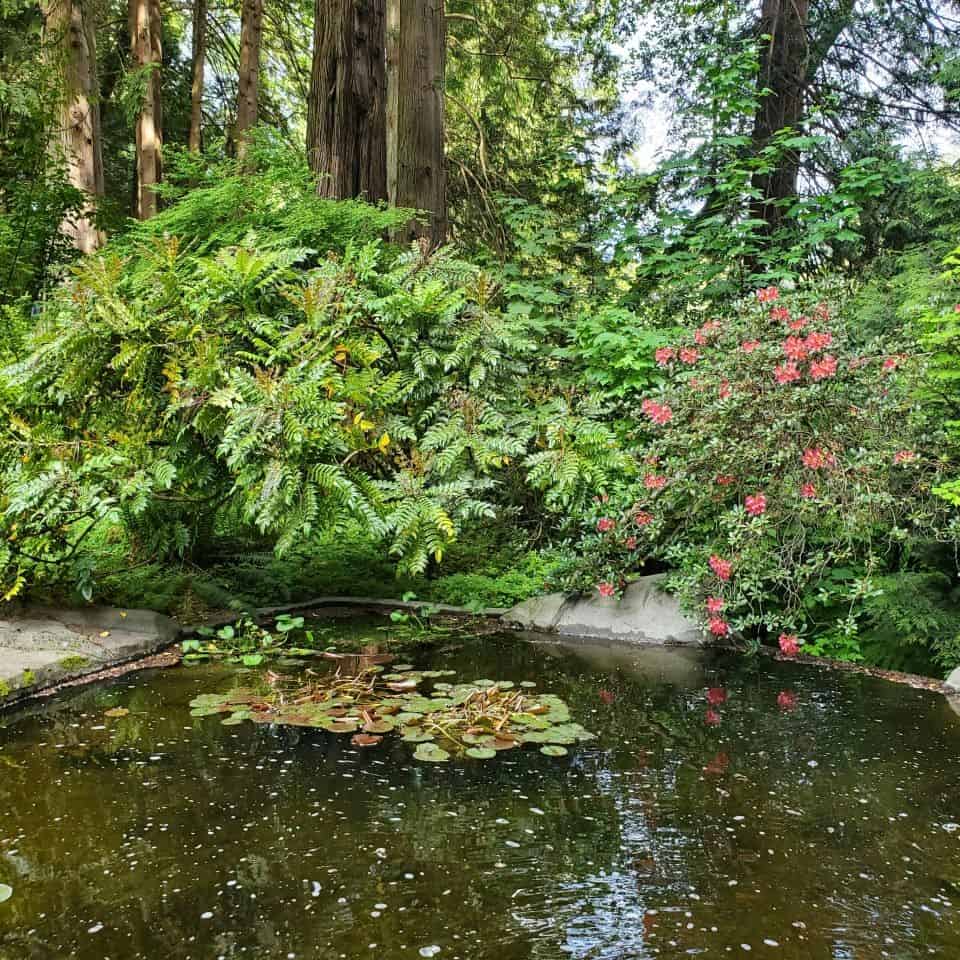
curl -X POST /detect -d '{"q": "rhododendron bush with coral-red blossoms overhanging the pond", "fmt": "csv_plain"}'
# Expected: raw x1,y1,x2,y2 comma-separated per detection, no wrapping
568,287,954,655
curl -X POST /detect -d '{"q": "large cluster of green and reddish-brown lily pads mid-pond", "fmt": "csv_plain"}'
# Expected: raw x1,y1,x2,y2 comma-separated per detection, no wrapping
190,658,594,763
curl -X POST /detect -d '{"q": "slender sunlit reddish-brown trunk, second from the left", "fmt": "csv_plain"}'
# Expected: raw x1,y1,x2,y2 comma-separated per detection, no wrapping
129,0,163,220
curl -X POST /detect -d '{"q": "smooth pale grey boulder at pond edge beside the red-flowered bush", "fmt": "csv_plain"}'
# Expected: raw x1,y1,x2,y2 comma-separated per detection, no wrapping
503,574,704,644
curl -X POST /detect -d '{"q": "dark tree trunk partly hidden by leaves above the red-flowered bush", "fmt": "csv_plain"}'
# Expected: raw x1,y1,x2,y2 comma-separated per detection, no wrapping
751,0,810,232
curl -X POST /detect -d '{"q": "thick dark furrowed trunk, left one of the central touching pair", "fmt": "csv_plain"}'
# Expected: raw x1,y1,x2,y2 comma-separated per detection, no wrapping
307,0,387,200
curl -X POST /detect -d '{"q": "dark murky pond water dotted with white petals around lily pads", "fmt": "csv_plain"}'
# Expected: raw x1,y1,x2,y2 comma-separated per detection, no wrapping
0,638,960,960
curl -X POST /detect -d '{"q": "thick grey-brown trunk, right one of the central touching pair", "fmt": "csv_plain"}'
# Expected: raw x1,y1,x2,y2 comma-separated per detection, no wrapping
387,0,447,246
